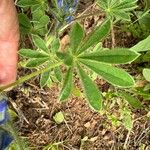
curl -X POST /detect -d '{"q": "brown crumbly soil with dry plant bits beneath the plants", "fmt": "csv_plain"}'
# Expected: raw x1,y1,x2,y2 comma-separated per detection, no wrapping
8,1,150,150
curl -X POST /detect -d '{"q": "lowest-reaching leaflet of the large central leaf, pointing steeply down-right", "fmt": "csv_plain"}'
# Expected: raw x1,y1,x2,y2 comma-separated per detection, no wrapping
78,65,102,111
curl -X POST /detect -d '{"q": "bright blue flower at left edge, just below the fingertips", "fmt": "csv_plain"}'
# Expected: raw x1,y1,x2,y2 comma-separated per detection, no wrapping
0,99,8,125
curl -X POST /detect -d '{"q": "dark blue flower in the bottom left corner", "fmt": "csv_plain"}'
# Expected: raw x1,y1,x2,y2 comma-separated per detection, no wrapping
0,128,13,150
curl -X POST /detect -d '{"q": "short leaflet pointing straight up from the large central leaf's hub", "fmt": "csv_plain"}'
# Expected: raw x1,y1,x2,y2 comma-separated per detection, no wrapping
70,22,84,52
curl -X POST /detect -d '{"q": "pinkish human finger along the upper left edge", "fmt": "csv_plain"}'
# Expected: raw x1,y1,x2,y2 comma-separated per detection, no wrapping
0,0,19,86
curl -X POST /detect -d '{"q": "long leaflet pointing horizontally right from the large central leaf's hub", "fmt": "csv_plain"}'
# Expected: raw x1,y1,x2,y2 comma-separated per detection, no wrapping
79,48,139,64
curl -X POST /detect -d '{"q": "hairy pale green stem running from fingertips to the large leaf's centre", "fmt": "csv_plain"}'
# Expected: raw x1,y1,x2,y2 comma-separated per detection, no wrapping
0,61,62,93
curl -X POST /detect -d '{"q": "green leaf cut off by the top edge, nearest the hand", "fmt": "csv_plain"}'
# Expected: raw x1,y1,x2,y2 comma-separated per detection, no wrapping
17,0,40,7
